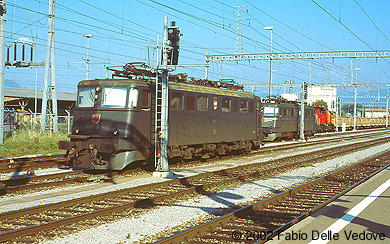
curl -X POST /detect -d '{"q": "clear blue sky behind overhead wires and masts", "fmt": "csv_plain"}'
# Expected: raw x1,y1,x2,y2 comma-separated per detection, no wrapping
5,0,390,106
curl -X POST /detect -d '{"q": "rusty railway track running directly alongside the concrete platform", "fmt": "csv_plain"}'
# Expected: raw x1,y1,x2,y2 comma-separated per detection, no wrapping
157,150,390,244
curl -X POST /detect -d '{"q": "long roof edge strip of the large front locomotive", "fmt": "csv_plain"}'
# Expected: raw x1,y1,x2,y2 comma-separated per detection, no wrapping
78,79,258,99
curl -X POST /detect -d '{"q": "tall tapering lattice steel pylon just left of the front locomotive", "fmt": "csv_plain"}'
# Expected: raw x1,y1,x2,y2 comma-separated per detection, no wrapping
41,0,58,133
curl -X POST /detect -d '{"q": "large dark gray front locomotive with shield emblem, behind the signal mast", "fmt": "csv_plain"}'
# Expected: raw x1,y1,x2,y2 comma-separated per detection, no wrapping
59,66,262,170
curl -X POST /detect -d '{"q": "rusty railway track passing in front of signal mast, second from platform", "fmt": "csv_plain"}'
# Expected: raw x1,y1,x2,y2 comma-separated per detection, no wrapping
0,133,390,242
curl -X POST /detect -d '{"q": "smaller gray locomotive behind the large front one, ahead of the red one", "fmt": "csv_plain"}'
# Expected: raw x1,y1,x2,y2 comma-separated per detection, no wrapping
262,97,316,141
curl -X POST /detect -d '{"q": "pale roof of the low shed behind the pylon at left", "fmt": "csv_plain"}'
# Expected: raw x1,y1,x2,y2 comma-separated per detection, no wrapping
4,87,77,101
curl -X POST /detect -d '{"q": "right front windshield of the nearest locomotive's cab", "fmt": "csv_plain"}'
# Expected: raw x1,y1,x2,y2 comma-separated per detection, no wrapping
102,87,127,108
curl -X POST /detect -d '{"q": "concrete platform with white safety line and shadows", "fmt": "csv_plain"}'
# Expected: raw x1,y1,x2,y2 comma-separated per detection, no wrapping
267,165,390,244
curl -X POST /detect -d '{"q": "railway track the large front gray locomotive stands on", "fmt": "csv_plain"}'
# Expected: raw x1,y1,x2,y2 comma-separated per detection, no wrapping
0,131,383,196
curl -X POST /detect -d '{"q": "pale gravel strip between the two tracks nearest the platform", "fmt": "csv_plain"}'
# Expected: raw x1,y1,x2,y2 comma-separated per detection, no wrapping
38,143,390,244
